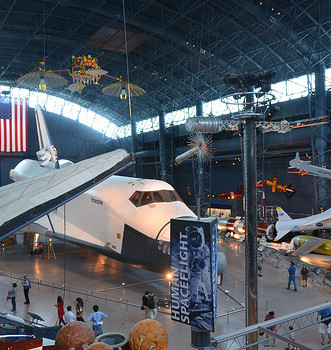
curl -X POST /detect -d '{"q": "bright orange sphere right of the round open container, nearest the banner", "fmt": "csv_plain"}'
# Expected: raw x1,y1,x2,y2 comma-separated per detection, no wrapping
129,319,168,350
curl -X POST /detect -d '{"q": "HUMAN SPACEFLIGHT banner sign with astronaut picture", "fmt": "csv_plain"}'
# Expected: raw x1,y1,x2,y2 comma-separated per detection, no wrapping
170,218,217,332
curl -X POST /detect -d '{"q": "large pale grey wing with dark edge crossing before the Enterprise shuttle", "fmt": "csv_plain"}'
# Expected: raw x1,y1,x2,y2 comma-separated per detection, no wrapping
0,150,132,239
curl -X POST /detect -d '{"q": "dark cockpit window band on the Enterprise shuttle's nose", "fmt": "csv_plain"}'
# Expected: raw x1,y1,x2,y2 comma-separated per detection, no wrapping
130,190,182,207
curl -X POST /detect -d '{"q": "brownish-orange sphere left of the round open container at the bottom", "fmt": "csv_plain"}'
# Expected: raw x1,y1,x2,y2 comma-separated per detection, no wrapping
55,321,95,350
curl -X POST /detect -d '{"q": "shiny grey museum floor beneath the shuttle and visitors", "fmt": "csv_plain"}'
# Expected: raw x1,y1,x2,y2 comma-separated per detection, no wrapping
0,234,330,350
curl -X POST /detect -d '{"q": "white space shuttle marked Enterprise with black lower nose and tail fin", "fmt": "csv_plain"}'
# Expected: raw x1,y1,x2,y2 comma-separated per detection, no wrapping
0,106,226,273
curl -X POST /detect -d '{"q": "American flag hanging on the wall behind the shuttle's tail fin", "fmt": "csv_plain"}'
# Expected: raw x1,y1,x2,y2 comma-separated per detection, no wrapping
0,97,28,152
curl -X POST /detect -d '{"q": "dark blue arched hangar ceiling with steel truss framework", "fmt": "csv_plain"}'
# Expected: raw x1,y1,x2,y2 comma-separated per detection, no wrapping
0,0,331,125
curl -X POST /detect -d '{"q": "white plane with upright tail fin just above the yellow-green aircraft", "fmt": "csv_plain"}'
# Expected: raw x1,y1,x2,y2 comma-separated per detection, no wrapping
274,207,331,242
